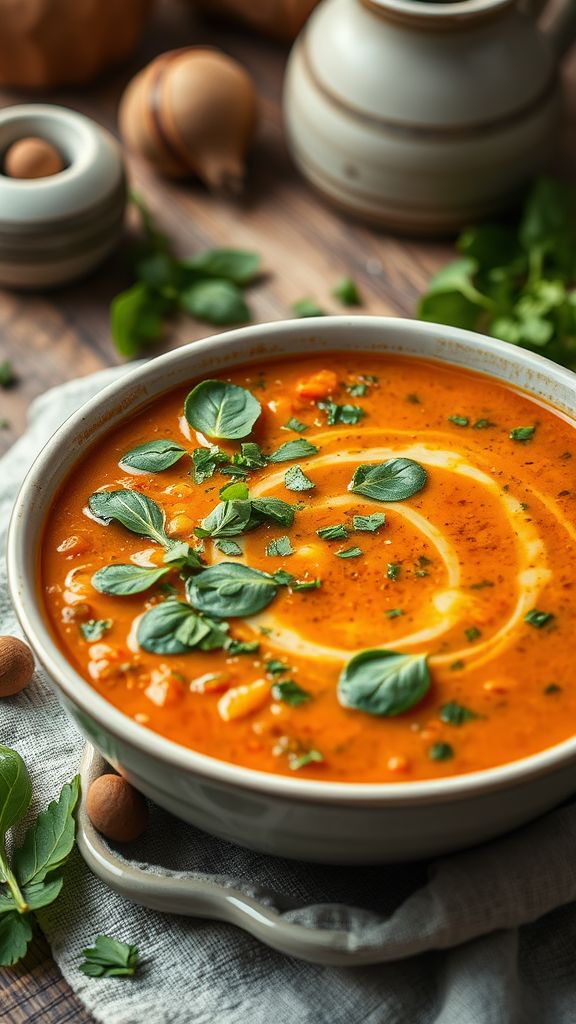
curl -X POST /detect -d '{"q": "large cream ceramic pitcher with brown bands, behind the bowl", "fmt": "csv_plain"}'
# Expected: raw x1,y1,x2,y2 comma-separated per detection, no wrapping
284,0,576,233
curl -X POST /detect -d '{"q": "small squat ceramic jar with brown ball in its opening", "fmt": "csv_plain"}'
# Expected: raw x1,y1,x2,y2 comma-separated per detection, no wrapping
0,103,126,288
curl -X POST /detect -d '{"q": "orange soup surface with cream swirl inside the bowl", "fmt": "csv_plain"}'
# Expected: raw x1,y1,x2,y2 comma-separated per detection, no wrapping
41,352,576,782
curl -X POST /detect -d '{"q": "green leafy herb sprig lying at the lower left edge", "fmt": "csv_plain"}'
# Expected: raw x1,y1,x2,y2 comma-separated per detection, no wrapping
0,744,80,967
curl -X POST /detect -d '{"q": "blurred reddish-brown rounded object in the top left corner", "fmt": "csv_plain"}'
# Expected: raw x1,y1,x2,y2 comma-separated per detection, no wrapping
0,0,152,88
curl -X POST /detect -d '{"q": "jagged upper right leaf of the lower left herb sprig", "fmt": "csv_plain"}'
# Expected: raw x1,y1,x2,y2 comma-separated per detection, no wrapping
13,775,80,888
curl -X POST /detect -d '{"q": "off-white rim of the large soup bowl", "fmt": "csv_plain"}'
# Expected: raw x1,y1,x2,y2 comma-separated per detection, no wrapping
6,314,576,806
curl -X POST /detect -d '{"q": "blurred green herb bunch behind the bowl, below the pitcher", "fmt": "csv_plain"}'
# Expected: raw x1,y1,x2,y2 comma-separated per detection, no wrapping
418,178,576,369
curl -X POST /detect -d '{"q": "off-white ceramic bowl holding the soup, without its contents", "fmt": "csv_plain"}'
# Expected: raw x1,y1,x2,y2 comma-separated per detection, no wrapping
8,316,576,864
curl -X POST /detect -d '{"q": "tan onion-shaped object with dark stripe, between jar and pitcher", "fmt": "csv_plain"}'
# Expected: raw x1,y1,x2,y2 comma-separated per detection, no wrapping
119,47,256,193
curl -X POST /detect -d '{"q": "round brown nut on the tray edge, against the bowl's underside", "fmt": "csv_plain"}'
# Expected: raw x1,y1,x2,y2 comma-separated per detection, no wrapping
86,773,148,843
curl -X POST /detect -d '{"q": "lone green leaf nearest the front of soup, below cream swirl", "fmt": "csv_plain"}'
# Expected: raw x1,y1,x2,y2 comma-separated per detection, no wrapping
338,649,430,717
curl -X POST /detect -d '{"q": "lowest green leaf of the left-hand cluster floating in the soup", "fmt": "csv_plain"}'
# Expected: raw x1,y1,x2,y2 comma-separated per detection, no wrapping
136,598,228,654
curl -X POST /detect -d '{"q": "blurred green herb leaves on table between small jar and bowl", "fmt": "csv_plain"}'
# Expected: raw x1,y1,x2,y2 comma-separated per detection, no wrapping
111,194,260,358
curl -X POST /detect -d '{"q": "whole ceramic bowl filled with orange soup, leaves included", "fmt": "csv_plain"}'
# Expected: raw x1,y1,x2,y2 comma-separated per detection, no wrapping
8,316,576,863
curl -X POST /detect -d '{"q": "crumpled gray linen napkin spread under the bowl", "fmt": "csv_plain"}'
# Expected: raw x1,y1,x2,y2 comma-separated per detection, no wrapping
0,369,576,1024
